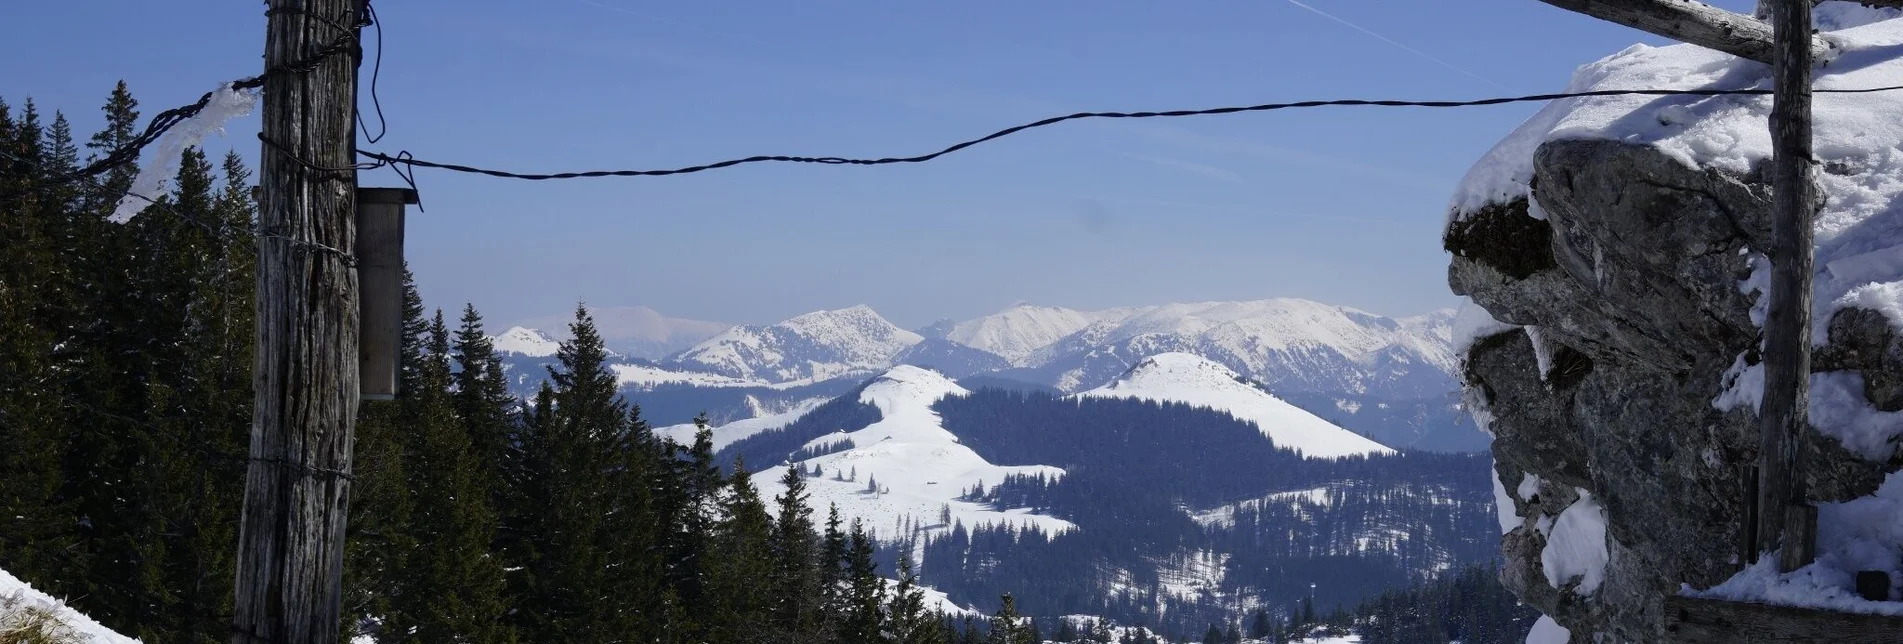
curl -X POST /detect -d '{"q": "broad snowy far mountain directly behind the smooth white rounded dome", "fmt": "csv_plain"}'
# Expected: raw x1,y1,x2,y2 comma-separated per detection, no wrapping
1024,299,1456,398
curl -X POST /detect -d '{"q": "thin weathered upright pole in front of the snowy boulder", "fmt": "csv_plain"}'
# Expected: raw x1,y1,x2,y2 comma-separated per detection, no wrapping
1756,0,1817,572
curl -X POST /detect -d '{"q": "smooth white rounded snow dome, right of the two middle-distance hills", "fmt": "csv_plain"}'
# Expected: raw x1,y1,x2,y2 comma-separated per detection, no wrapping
1081,352,1395,457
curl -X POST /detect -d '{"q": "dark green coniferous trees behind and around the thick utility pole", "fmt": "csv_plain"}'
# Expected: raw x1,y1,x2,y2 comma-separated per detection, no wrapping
0,84,957,642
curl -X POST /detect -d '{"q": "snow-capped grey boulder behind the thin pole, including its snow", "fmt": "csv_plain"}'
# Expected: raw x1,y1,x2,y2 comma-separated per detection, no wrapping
1442,4,1903,642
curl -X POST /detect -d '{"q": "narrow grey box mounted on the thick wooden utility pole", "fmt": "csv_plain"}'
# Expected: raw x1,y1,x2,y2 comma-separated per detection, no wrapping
356,189,417,400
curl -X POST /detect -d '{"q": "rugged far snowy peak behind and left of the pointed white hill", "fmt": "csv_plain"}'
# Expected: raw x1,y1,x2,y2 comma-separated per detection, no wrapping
668,305,923,383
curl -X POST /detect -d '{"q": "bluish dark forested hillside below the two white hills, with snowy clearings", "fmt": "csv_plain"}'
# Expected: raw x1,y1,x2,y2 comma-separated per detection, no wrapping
923,391,1496,633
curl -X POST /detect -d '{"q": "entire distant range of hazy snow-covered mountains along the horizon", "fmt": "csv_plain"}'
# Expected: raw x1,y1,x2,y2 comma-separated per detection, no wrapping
497,299,1486,450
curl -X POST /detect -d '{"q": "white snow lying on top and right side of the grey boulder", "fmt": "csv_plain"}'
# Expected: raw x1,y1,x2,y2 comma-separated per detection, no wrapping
1448,2,1903,617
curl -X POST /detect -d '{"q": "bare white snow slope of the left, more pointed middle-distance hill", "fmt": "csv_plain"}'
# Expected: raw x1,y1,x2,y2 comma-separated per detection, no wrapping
754,366,1075,539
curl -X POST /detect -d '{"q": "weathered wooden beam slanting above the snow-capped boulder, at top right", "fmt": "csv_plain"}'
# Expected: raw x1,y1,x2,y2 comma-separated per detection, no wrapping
1540,0,1826,63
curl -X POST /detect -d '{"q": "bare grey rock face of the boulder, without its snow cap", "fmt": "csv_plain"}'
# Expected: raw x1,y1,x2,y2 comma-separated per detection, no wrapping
1444,139,1903,642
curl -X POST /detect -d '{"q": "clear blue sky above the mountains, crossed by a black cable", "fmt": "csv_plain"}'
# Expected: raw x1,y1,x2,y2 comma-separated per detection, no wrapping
0,0,1753,326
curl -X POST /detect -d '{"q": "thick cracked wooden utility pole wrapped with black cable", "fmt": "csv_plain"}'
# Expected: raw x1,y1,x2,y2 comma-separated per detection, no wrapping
232,0,363,644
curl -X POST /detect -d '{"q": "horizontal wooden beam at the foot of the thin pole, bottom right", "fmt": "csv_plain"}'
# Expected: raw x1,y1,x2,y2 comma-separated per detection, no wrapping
1665,594,1903,644
